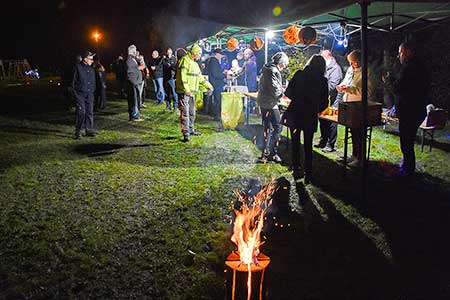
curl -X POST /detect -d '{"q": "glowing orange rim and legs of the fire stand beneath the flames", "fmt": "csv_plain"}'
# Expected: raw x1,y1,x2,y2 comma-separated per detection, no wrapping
225,252,270,300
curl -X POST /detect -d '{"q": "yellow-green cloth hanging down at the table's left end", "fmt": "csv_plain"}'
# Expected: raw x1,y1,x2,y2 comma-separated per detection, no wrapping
222,93,244,129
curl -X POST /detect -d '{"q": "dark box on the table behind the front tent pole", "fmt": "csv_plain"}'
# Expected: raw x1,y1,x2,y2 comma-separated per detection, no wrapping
338,101,382,127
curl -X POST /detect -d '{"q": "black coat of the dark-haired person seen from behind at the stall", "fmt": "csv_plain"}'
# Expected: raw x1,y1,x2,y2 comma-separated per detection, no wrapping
283,67,328,131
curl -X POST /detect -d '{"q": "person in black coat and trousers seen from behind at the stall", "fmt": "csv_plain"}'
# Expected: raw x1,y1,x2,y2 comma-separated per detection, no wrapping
283,54,329,184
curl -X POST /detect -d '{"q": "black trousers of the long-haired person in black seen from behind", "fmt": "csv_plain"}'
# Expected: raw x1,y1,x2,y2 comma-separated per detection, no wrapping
290,128,314,175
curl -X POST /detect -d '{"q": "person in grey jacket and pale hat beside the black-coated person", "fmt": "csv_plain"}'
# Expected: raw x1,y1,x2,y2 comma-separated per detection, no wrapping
256,52,289,163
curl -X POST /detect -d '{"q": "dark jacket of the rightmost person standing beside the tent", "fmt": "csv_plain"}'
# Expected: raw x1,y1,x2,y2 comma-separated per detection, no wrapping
393,59,430,122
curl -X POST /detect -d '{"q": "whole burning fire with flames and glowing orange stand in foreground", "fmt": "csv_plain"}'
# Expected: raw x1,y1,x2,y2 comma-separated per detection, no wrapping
225,182,275,300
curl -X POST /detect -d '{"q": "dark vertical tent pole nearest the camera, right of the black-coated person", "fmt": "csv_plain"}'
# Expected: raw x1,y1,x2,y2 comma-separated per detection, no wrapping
360,1,369,205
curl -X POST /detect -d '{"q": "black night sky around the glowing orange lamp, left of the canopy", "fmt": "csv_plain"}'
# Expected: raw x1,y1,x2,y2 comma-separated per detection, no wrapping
0,0,170,69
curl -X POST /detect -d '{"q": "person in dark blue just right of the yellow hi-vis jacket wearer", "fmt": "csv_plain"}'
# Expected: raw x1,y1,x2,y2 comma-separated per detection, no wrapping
207,48,229,121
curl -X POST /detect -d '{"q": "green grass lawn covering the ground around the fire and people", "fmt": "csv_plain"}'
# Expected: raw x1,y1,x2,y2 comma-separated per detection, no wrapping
0,81,450,299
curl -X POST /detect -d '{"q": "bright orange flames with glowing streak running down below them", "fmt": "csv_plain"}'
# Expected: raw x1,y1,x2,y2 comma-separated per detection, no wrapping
231,181,275,300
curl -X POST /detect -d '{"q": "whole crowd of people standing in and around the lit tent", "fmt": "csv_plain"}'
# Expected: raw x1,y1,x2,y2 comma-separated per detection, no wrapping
67,42,429,182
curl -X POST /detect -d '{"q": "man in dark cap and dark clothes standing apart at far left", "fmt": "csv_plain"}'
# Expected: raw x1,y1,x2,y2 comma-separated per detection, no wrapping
69,51,96,139
